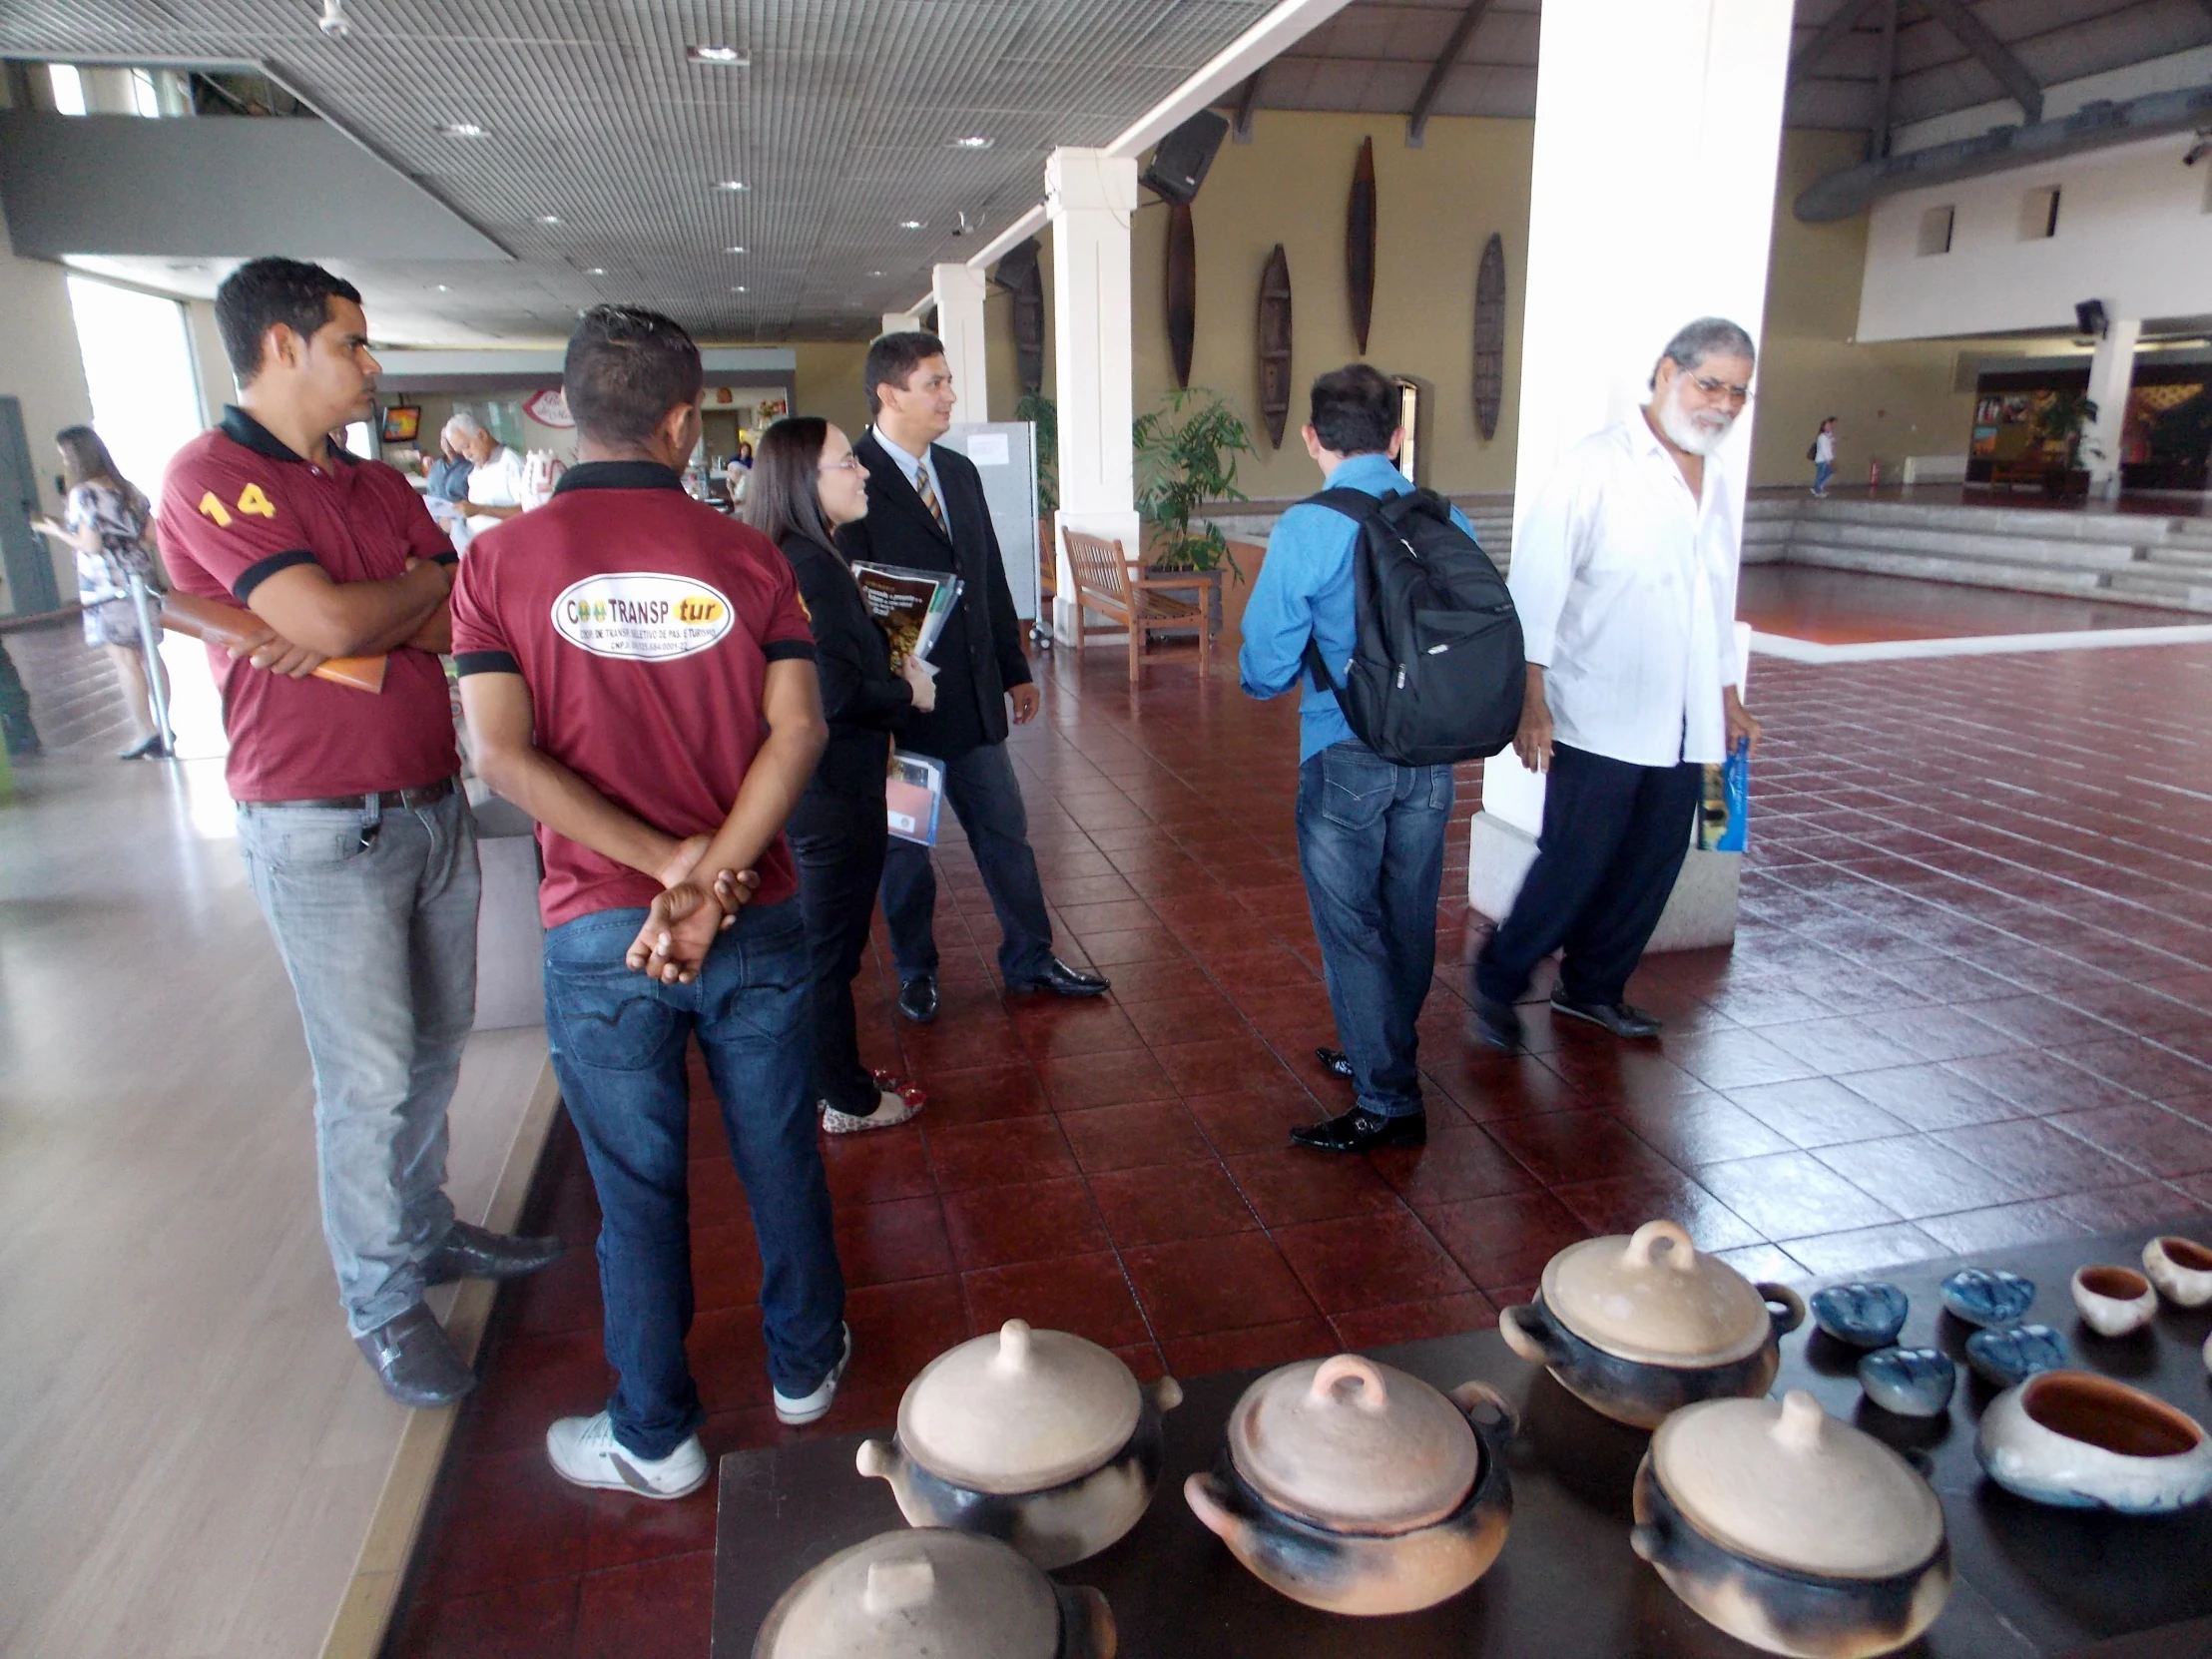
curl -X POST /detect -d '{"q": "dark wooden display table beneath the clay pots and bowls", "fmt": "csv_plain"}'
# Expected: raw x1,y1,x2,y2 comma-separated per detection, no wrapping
715,1217,2212,1659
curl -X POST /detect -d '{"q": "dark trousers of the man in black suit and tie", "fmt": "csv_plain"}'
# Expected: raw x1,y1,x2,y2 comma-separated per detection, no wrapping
882,744,1053,984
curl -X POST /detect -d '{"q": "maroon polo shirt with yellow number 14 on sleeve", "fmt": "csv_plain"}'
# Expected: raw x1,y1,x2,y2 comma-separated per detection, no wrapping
160,409,460,801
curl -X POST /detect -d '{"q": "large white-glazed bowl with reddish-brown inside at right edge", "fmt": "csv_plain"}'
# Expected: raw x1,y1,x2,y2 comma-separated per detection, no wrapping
1973,1372,2212,1515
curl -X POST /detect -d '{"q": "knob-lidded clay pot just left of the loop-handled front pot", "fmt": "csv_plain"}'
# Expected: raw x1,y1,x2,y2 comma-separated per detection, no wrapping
858,1319,1184,1568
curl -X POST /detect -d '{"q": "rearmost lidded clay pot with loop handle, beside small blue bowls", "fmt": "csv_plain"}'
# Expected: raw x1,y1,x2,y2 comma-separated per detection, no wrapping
1497,1221,1805,1429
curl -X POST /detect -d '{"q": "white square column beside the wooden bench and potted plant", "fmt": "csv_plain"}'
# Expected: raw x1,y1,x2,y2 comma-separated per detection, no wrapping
1044,151,1141,642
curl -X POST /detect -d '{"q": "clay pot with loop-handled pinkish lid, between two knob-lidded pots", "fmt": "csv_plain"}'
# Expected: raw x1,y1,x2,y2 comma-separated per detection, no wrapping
1184,1354,1515,1615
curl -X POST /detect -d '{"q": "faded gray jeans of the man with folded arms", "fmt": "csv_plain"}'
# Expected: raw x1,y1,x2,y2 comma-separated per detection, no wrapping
239,788,478,1336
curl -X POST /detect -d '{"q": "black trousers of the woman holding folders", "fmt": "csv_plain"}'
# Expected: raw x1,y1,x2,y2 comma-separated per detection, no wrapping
786,792,889,1117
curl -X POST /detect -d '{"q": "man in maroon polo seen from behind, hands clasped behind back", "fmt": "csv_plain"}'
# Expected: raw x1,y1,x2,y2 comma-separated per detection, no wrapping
453,305,851,1497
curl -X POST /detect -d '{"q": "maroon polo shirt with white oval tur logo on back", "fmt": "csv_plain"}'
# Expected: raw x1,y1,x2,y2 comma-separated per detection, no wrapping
453,460,814,927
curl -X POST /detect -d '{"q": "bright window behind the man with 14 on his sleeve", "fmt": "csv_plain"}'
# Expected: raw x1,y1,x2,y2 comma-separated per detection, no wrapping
65,276,202,500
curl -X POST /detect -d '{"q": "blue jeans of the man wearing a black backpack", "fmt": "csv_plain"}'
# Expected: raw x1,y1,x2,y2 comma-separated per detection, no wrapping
1299,744,1451,1117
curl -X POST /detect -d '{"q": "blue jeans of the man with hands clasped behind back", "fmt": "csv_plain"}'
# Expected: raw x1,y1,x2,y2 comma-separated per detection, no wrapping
546,900,845,1457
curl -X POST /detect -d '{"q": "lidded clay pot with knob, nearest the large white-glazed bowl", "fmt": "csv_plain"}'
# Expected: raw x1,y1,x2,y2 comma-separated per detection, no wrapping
1628,1389,1953,1659
